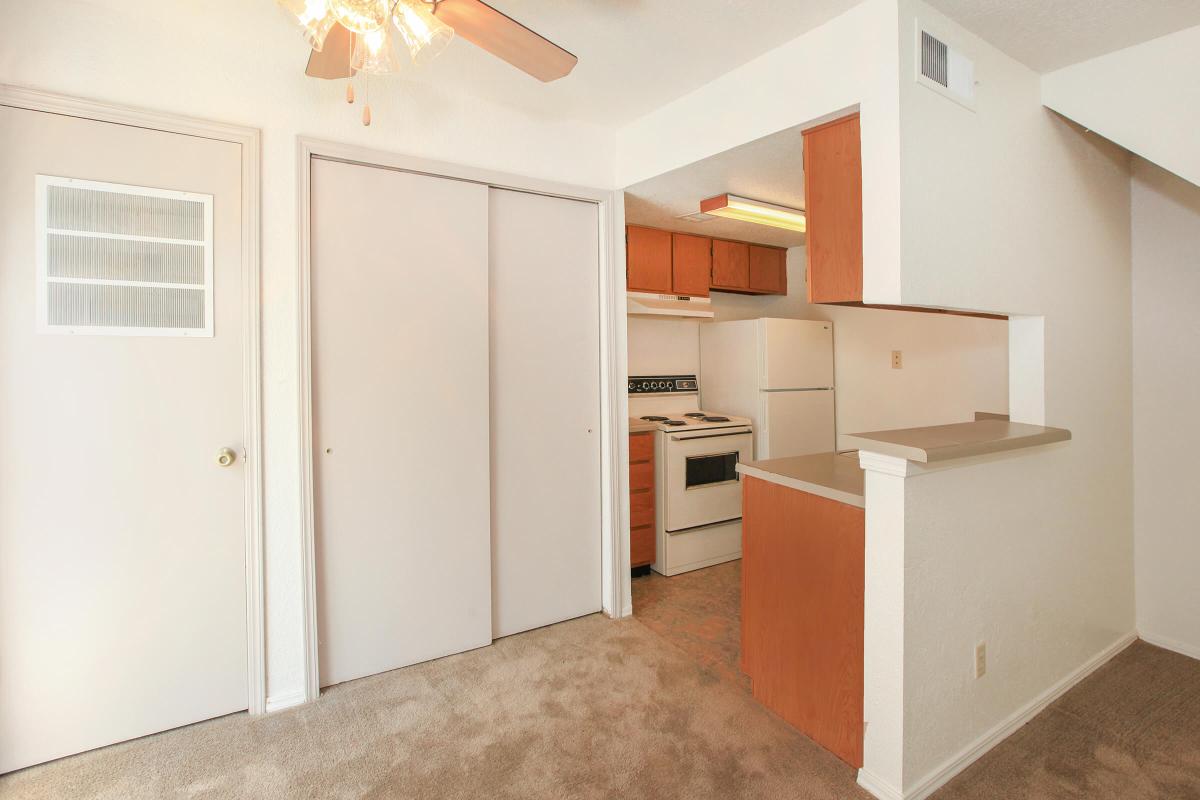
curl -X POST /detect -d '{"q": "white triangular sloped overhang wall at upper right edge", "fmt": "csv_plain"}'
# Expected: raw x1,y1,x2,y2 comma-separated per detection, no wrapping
1042,25,1200,184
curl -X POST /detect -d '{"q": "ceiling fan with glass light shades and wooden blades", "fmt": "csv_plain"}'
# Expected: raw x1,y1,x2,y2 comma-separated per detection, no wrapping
276,0,578,125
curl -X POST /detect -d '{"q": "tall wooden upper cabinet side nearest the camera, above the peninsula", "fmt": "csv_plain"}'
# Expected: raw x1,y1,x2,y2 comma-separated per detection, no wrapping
804,114,863,302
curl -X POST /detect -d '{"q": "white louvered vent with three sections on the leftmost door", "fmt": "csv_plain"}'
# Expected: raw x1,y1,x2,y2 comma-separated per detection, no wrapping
37,175,212,336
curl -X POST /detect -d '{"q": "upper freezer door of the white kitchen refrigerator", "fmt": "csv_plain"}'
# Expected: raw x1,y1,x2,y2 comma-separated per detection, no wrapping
758,319,833,390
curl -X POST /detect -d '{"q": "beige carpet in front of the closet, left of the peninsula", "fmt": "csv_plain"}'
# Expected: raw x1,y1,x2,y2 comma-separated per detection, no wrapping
0,616,869,800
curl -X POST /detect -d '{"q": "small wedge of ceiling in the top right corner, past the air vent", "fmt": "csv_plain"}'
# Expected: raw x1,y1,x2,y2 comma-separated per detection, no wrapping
928,0,1200,72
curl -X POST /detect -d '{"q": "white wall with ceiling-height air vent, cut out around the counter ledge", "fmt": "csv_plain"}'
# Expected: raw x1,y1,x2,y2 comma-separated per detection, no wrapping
888,0,1134,787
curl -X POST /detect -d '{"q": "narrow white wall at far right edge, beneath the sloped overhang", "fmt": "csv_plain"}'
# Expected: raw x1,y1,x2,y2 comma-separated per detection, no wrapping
1133,158,1200,658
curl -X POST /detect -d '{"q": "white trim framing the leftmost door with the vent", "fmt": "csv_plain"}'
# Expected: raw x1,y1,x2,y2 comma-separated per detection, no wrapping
0,84,266,714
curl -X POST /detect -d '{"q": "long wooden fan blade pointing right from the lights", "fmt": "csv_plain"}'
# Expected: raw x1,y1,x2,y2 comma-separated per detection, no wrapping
436,0,580,83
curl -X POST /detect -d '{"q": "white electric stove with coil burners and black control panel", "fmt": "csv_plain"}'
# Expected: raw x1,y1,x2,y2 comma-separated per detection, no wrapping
629,375,754,576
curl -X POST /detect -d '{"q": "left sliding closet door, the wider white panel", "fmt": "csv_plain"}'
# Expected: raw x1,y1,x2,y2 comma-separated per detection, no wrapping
311,160,492,686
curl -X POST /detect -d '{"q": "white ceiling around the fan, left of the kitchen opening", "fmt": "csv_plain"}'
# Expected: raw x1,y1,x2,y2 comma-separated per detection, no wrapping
296,0,862,125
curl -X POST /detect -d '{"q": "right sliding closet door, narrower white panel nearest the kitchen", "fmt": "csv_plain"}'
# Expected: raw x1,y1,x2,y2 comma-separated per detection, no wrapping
490,188,601,637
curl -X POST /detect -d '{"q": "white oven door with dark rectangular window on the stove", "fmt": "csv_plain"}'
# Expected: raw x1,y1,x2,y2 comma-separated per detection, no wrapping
664,426,754,533
